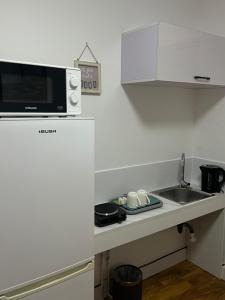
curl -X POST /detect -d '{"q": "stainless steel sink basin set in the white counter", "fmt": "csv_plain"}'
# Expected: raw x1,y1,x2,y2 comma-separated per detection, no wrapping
152,186,214,205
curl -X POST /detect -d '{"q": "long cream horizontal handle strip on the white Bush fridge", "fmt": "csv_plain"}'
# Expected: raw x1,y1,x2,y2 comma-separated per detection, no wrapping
0,260,94,300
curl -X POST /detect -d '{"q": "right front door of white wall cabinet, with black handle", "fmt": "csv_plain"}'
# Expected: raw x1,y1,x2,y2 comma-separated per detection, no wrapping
195,33,225,85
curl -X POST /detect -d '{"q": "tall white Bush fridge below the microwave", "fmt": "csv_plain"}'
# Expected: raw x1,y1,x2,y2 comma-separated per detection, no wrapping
0,118,94,300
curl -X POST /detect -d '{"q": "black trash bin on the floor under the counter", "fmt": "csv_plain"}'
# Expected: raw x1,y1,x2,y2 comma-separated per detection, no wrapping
112,265,142,300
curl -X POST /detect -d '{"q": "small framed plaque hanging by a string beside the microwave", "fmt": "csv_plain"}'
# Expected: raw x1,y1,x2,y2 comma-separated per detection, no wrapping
74,43,101,95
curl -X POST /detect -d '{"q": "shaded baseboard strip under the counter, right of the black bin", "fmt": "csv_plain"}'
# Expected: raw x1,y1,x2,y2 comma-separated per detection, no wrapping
141,249,187,279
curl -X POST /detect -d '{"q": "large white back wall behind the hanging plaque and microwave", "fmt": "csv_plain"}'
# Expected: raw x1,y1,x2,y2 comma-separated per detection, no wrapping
0,0,202,170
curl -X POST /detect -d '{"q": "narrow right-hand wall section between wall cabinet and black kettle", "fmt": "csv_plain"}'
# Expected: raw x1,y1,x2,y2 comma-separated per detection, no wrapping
193,89,225,162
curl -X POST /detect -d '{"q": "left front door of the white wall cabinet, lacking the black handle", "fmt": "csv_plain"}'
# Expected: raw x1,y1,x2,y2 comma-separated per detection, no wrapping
157,23,201,83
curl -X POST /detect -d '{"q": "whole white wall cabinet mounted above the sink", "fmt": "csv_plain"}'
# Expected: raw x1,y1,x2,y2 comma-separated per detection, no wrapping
121,23,225,88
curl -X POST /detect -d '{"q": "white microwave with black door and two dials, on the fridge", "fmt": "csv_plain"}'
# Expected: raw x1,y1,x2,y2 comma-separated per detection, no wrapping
0,60,81,117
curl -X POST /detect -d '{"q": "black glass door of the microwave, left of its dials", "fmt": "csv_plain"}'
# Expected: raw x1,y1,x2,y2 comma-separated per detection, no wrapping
0,62,66,113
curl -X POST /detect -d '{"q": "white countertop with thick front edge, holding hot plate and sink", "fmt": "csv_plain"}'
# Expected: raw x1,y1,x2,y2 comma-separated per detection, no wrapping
95,194,225,254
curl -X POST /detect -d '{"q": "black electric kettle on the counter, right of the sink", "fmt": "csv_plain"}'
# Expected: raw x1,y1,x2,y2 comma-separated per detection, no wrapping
200,165,225,193
